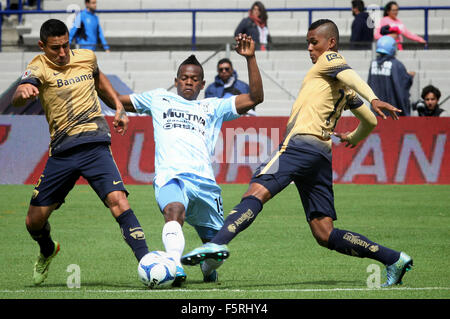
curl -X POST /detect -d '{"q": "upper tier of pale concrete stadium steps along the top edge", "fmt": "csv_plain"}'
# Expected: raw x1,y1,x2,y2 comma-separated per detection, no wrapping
10,0,450,48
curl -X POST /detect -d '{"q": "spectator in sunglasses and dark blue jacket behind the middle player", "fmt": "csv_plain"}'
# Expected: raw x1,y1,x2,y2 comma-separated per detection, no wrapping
205,58,256,115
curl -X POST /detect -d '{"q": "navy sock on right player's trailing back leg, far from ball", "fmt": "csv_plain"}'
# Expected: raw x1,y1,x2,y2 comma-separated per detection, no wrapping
328,228,400,265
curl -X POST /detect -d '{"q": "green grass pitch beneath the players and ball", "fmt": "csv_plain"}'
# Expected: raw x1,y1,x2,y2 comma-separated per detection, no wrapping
0,185,450,299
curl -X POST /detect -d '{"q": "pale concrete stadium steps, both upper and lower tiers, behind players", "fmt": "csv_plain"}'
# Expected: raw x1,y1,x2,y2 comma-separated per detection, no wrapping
0,0,450,116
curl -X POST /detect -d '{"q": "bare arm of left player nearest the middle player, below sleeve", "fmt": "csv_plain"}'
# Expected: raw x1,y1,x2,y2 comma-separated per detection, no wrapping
95,70,129,135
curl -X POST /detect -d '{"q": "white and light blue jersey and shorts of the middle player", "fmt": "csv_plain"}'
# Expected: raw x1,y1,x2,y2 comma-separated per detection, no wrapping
130,89,239,234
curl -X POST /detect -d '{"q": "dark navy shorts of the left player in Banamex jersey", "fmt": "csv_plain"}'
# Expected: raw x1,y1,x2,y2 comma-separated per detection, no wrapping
30,143,128,208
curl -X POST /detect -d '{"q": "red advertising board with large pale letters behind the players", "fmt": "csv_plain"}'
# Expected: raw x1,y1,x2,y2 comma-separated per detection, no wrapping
0,115,450,185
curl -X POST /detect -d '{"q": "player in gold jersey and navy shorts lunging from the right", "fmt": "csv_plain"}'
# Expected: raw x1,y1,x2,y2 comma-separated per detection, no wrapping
181,19,412,287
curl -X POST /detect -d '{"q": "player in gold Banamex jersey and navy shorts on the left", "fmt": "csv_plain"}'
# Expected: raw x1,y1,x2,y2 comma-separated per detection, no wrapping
12,19,148,285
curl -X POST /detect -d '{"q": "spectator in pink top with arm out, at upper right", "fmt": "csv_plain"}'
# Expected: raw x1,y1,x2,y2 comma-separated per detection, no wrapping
375,1,427,50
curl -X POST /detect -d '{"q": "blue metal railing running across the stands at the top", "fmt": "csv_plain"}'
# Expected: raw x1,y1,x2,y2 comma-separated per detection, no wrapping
0,1,450,52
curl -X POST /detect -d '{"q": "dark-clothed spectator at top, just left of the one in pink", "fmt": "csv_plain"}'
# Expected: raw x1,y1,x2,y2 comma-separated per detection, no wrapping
350,0,373,50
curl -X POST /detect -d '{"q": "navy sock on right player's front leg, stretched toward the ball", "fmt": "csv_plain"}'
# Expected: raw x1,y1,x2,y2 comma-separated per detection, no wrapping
211,196,263,245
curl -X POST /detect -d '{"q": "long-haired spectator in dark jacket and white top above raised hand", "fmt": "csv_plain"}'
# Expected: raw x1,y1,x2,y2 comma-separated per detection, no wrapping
234,1,272,51
